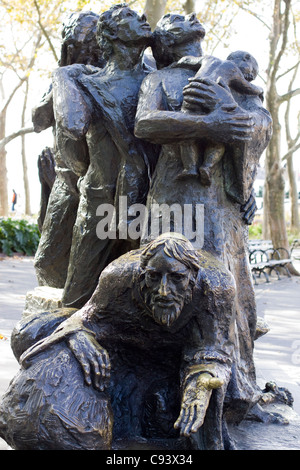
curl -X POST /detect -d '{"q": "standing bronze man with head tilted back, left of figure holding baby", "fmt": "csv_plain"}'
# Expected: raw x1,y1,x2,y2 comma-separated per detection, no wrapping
53,4,155,308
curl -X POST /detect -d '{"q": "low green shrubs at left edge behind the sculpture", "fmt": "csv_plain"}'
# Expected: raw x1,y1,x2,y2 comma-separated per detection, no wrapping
0,218,40,256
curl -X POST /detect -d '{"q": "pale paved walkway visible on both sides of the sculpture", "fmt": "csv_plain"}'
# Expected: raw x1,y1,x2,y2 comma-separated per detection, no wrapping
0,257,300,450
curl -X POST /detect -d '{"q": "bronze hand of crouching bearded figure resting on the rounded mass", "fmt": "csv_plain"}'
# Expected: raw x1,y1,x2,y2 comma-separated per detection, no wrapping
68,331,110,391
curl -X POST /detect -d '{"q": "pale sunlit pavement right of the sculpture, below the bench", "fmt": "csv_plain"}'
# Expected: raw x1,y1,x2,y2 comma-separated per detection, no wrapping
254,267,300,414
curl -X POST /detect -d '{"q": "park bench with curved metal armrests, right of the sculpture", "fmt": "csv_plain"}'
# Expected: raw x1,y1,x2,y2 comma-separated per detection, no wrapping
248,240,292,285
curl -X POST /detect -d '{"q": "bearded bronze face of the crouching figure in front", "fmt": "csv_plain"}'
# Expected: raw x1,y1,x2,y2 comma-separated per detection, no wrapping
143,250,192,327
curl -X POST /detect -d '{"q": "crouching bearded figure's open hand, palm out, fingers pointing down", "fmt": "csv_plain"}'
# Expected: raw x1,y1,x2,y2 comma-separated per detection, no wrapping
174,372,223,436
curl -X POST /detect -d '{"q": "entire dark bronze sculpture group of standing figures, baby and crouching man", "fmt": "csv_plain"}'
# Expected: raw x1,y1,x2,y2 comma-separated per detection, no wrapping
0,4,272,450
